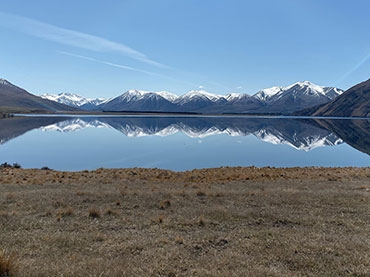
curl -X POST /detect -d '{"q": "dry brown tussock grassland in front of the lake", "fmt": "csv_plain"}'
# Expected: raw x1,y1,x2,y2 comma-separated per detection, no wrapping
0,167,370,276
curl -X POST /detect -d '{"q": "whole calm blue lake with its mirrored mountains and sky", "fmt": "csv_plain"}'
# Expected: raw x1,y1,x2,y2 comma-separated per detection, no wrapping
0,116,370,171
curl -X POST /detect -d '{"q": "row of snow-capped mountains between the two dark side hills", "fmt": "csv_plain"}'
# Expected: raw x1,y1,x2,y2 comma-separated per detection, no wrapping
42,81,343,114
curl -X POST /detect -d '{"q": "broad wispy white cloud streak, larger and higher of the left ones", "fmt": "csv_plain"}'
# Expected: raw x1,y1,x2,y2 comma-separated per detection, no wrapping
0,12,168,68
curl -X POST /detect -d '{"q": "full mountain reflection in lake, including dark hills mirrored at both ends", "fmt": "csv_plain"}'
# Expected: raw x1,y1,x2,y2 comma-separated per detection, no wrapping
0,116,370,154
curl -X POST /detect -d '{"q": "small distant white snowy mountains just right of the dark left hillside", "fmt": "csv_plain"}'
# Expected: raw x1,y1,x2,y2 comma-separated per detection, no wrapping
40,93,107,110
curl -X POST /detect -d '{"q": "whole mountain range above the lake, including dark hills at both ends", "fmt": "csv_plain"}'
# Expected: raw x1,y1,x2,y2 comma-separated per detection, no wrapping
0,76,370,117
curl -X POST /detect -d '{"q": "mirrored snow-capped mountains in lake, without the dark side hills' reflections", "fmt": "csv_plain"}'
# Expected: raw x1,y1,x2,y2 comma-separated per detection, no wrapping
36,117,343,151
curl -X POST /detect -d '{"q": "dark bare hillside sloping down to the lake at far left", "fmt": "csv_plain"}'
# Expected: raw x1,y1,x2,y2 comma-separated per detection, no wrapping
0,79,76,112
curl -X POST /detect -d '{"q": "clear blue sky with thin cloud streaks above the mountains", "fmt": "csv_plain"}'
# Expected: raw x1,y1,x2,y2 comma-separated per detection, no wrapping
0,0,370,97
